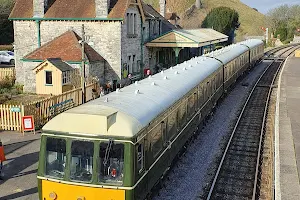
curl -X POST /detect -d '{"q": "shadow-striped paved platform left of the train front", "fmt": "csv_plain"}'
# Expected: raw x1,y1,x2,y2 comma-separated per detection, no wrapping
0,131,40,200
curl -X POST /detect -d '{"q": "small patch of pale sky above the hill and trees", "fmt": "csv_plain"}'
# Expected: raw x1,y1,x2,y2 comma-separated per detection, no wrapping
240,0,300,14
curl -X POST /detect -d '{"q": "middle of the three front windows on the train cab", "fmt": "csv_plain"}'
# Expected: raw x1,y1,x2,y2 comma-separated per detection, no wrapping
70,140,94,182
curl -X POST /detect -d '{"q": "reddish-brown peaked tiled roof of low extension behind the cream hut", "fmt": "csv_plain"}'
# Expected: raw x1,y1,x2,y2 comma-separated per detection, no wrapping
24,31,104,62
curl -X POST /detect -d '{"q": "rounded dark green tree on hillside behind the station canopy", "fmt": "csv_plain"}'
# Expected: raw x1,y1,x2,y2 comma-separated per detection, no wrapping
201,7,240,44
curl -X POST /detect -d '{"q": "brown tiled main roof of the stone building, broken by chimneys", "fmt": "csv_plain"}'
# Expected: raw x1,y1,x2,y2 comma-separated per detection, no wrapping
9,0,139,18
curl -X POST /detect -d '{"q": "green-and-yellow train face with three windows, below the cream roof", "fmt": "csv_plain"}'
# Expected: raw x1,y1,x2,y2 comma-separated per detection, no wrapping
38,134,131,200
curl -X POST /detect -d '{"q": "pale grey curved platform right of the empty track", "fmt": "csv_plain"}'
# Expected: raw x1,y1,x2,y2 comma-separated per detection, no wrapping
275,54,300,200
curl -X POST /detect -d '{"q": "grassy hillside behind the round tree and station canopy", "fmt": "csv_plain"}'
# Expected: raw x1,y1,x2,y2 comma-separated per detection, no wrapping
144,0,265,41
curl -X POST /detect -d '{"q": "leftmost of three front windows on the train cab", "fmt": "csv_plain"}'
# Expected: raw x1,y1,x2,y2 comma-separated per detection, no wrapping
45,138,66,178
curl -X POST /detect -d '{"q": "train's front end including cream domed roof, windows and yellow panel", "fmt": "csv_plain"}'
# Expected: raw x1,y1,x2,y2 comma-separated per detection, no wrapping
37,104,141,200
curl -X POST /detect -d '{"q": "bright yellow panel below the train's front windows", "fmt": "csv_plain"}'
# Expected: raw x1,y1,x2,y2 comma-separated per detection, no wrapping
42,180,125,200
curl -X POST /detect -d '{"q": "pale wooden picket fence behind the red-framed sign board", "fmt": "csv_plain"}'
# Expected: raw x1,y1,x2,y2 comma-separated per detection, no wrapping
0,84,99,131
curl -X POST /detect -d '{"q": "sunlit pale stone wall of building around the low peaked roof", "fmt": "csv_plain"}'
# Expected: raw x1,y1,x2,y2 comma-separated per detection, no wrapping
14,21,121,92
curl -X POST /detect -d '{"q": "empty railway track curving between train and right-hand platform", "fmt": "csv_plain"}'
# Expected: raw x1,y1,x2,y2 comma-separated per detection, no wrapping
206,47,298,200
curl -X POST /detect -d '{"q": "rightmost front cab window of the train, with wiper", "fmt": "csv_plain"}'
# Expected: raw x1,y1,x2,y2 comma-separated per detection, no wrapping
99,140,124,183
